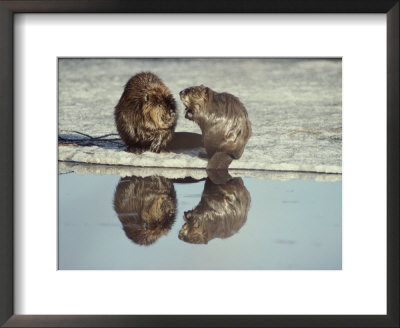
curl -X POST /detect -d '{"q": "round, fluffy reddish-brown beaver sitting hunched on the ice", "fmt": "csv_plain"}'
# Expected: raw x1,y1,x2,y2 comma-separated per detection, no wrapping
114,72,178,154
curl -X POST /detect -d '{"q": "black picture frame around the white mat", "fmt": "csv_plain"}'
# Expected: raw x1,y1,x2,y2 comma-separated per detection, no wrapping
0,0,400,327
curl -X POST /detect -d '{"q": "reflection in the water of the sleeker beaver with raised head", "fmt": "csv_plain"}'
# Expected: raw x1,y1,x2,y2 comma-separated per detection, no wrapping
179,178,251,244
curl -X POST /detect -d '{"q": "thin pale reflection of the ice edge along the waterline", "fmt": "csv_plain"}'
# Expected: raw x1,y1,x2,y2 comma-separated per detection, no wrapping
58,161,342,182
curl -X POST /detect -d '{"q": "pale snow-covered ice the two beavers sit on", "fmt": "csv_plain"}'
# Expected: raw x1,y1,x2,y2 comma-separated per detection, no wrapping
58,58,342,179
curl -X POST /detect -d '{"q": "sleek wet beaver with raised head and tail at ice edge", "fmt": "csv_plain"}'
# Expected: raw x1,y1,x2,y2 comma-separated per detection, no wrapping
179,85,251,169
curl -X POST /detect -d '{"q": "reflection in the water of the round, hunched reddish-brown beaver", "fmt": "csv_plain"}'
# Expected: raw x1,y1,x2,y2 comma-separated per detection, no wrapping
114,176,176,245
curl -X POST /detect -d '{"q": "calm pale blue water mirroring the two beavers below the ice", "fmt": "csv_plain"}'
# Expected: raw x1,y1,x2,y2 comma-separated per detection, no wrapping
58,170,342,270
